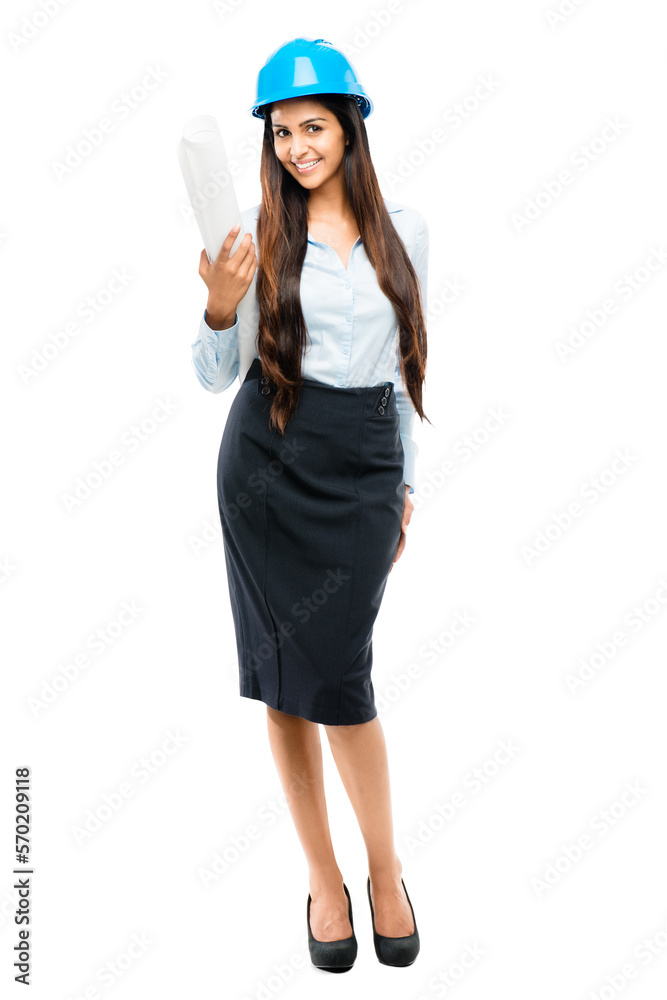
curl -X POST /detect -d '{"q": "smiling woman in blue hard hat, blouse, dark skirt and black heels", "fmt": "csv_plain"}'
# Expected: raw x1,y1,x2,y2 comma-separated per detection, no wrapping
192,38,428,972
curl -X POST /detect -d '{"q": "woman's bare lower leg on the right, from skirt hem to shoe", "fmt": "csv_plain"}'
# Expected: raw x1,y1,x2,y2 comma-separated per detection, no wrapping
324,716,415,937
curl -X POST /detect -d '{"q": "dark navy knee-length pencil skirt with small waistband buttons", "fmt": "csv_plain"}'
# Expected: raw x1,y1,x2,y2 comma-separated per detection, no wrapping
218,358,405,726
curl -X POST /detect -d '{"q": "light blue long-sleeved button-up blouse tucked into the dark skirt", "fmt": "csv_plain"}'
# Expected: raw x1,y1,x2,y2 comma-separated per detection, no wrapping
191,198,429,493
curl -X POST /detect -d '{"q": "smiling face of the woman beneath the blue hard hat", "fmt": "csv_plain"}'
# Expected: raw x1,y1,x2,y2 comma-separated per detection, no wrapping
271,97,349,190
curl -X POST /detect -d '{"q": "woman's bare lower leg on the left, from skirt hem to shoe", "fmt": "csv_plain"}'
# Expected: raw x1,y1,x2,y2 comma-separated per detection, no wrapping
267,705,352,941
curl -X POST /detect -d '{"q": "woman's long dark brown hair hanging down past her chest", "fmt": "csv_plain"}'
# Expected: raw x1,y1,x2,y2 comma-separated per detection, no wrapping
257,94,431,433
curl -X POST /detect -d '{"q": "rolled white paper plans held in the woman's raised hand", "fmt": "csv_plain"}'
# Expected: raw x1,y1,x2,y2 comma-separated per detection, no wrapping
178,115,257,382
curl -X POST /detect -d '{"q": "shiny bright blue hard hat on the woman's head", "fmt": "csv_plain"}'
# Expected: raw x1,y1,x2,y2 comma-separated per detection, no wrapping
248,38,373,119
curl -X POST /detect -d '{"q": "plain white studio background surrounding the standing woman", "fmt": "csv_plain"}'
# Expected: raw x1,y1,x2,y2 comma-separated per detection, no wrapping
0,0,667,1000
